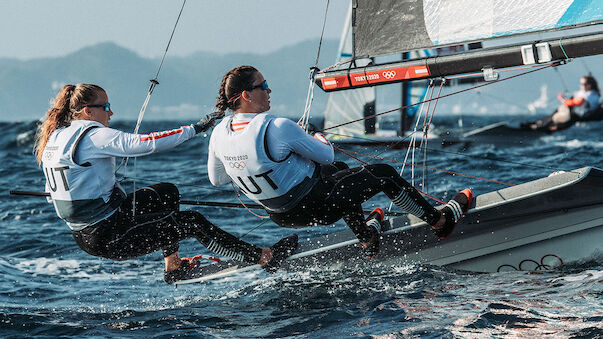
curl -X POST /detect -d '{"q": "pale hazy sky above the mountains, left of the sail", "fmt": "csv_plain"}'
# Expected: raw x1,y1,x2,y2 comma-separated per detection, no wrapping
0,0,350,60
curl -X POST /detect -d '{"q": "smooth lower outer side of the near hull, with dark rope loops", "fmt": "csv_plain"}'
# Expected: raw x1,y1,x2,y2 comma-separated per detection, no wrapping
384,203,603,272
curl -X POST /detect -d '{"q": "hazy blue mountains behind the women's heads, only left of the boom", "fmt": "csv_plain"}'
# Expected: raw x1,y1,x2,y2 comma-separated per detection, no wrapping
0,40,338,120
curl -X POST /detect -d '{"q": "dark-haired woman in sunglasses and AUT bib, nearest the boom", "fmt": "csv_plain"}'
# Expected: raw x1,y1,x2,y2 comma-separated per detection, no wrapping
208,66,472,257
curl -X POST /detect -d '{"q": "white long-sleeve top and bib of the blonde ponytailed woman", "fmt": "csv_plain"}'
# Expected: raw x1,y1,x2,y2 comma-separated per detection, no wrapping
42,120,196,230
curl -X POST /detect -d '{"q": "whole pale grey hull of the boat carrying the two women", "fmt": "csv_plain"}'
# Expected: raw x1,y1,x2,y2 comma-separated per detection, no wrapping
288,168,603,272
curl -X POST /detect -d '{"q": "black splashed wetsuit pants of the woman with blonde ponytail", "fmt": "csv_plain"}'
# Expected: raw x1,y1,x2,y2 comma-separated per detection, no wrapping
73,183,262,263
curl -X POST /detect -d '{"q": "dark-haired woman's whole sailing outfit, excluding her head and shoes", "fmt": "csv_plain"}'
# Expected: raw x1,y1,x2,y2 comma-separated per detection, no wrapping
208,113,441,241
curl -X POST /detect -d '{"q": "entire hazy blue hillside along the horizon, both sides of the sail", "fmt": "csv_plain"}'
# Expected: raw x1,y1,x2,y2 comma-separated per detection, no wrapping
0,40,603,120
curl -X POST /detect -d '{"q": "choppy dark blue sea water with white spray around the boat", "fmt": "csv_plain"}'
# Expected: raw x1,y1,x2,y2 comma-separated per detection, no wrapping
0,117,603,338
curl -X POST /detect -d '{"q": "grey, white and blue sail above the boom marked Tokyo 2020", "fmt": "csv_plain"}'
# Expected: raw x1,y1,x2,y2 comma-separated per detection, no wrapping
353,0,603,57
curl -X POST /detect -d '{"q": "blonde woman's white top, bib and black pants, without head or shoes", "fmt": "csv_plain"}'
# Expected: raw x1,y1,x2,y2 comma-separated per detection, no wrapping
42,120,261,263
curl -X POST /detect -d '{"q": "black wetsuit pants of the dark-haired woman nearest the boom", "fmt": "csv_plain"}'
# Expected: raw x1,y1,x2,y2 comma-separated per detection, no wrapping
270,162,441,242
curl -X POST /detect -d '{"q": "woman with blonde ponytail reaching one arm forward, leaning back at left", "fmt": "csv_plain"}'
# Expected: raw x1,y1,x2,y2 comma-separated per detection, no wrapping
34,84,294,283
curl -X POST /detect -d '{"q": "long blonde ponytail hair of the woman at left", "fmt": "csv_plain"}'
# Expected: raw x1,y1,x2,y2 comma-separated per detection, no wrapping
33,84,104,164
